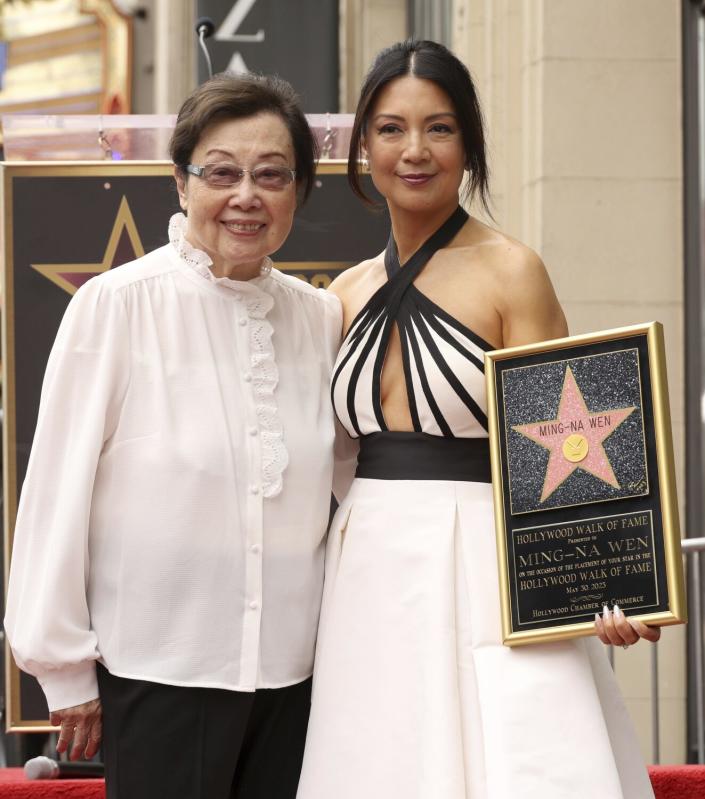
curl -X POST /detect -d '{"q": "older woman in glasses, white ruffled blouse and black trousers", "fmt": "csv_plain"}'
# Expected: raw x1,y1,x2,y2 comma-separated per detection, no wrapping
5,75,341,799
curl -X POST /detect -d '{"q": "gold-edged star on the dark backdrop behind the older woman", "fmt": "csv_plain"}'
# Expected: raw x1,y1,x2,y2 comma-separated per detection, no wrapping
31,197,144,294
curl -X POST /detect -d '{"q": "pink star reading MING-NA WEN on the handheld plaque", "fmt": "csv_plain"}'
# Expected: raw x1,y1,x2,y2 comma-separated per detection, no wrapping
512,367,636,502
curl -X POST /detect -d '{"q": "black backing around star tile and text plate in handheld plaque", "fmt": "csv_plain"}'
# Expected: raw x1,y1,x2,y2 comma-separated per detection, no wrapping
494,333,668,632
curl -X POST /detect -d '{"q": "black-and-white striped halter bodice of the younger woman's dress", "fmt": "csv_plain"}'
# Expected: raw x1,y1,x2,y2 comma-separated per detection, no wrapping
331,206,492,438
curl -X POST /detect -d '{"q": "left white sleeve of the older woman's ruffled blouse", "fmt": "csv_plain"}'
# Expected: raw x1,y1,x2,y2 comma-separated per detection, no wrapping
5,278,130,710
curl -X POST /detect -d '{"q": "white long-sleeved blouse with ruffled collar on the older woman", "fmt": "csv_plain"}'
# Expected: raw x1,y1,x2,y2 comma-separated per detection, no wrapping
5,214,342,710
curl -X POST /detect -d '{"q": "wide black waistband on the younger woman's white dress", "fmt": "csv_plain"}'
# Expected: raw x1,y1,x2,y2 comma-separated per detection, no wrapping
355,431,492,483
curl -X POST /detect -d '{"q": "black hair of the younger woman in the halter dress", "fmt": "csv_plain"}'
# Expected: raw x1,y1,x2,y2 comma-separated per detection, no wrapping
348,39,489,213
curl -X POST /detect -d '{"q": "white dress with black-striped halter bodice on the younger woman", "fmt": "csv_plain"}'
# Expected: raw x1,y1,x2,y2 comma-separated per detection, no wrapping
298,208,653,799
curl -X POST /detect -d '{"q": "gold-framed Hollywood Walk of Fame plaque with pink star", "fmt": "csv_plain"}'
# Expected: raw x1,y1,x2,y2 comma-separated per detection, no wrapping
485,322,686,646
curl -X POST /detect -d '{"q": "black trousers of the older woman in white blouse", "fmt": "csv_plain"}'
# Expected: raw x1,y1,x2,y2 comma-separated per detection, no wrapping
98,664,311,799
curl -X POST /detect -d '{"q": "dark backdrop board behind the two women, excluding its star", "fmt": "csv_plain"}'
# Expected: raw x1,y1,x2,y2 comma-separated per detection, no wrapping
3,163,389,731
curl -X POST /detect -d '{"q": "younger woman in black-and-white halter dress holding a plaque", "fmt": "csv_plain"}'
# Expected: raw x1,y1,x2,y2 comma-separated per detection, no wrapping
298,41,658,799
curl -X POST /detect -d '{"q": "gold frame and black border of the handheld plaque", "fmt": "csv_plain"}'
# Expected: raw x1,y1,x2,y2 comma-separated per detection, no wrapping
485,322,687,646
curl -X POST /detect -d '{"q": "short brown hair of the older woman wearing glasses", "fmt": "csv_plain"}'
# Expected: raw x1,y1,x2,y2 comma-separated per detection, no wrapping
169,72,318,202
